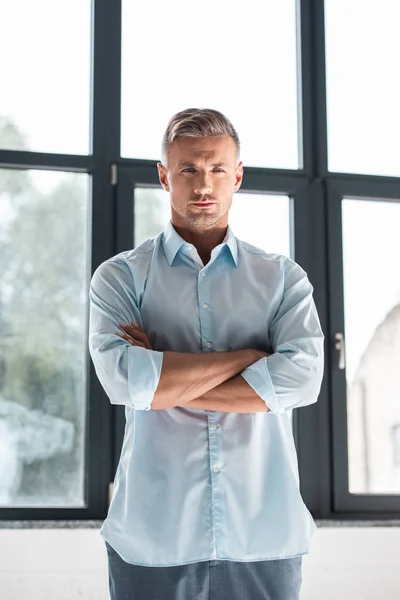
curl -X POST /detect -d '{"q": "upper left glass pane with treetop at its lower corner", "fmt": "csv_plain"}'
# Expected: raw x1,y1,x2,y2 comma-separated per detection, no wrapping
0,0,91,154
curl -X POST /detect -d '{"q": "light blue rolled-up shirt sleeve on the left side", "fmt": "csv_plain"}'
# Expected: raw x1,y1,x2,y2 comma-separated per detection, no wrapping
89,258,164,410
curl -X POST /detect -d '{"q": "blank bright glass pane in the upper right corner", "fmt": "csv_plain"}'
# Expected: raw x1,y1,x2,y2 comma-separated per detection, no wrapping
325,0,400,176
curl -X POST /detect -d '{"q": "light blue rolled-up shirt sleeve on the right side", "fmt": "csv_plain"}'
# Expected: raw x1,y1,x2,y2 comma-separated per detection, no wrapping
241,257,325,414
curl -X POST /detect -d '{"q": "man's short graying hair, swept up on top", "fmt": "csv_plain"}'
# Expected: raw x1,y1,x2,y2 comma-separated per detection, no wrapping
161,108,240,165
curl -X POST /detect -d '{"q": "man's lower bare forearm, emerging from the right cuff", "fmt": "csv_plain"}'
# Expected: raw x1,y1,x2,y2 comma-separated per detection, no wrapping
178,374,269,413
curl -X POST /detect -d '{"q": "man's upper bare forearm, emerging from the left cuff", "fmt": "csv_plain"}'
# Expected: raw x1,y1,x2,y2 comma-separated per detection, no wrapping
151,349,266,410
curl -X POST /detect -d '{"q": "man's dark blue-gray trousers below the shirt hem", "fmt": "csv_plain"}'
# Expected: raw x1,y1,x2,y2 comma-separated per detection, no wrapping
105,542,302,600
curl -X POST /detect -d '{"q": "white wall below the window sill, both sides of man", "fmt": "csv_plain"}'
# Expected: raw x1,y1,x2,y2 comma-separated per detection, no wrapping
0,526,400,600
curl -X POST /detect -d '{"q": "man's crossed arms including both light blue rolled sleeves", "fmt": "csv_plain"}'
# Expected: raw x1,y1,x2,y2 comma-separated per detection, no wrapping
89,258,324,414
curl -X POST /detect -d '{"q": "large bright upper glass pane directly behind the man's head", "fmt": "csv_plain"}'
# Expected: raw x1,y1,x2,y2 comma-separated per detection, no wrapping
121,0,299,169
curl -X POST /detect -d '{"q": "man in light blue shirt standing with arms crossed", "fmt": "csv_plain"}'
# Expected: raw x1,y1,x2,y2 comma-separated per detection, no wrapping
89,109,324,600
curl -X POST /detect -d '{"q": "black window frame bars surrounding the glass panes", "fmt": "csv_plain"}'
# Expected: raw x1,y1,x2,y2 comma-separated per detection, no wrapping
0,0,400,520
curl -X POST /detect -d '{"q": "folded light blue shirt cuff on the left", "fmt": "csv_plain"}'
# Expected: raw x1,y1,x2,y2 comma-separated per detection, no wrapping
128,346,164,410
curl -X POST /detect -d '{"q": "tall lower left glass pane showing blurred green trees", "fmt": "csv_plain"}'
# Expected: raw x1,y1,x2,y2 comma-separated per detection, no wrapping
0,169,90,507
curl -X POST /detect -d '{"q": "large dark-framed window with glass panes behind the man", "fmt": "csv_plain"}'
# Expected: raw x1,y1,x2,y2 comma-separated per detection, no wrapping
0,0,400,520
